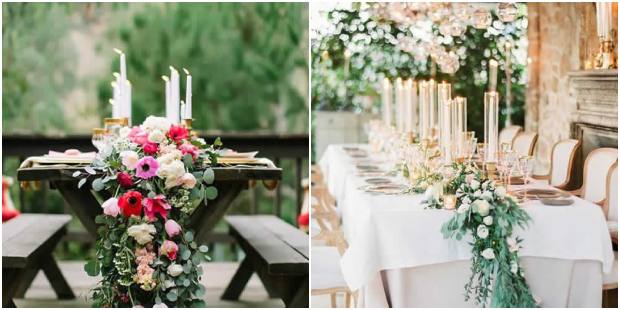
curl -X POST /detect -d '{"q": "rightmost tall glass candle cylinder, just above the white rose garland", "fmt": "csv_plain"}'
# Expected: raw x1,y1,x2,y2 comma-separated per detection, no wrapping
484,92,499,163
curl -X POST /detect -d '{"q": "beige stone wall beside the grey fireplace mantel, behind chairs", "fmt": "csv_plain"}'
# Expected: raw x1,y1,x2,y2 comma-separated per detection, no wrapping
525,2,617,172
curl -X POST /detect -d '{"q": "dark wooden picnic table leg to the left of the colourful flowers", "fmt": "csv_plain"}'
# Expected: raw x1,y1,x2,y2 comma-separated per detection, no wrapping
53,181,103,238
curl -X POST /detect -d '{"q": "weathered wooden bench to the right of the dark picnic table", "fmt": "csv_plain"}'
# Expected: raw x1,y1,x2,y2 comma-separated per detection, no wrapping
222,215,309,308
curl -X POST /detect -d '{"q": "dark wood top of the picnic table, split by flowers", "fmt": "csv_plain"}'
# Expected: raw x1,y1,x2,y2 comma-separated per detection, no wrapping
17,166,282,181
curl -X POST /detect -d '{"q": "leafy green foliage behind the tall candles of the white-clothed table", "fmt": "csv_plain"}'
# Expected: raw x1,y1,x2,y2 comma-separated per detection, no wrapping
311,5,527,136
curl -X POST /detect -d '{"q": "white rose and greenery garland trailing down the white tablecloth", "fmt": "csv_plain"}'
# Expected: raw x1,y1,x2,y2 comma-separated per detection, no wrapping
426,163,537,308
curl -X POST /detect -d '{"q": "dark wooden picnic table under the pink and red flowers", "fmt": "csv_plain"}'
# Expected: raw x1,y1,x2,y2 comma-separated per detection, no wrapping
17,166,282,241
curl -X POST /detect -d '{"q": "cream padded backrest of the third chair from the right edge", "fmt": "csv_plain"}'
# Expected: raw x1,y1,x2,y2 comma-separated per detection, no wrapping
549,139,581,188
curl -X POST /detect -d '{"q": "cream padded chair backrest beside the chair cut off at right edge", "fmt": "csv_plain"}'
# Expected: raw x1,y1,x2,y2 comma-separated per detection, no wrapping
581,147,618,203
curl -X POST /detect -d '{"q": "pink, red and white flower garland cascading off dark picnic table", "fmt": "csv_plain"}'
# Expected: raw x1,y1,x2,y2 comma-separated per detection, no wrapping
74,116,221,307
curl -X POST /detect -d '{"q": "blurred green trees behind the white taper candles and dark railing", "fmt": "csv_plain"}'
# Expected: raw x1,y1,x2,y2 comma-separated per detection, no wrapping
2,3,308,133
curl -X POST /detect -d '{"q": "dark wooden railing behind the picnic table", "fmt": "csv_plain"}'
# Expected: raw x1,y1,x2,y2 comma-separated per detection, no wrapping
2,131,309,247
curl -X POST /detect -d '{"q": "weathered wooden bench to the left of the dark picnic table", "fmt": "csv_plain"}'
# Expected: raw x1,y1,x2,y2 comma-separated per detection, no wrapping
2,214,75,308
